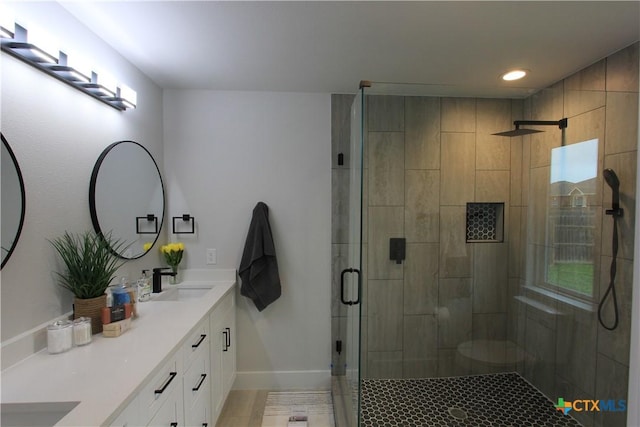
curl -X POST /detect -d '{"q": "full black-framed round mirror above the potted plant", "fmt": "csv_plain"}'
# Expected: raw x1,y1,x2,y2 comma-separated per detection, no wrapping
89,141,164,259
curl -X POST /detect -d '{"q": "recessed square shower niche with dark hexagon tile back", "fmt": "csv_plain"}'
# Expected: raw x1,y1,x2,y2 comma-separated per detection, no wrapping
466,203,504,243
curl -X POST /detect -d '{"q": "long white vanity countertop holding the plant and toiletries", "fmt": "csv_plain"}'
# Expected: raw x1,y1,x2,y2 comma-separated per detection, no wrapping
2,270,236,426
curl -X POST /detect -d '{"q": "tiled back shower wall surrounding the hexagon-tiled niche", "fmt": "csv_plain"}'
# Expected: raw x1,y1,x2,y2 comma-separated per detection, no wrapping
333,95,522,378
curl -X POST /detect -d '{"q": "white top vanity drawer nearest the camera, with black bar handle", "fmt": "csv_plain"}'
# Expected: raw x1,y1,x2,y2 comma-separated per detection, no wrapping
139,355,182,420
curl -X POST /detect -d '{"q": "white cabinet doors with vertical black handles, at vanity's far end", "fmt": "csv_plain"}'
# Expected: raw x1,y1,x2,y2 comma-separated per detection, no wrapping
210,292,236,422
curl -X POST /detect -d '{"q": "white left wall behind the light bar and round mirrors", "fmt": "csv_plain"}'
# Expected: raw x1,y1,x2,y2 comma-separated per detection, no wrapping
0,2,163,366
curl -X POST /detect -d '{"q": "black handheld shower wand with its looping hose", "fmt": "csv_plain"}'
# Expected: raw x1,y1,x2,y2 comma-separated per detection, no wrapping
598,169,623,331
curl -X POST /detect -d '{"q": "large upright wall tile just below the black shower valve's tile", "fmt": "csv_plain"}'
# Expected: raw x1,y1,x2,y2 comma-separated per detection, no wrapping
367,280,403,351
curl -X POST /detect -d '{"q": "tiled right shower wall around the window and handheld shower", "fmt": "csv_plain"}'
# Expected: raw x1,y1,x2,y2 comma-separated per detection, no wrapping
508,43,639,427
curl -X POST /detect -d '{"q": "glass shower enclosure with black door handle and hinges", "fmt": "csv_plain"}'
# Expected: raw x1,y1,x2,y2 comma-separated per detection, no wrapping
334,74,635,427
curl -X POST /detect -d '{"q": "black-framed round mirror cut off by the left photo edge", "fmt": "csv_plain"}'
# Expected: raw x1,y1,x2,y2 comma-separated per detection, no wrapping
0,133,25,268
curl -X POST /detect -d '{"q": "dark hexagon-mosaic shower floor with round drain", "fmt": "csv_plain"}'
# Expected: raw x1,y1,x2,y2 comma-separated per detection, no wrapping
361,373,580,427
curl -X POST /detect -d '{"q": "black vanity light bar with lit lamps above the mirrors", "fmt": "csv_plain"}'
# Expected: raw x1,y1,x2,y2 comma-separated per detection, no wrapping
0,23,137,111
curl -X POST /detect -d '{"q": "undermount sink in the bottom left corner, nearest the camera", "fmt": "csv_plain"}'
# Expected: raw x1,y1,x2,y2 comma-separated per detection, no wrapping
0,402,80,427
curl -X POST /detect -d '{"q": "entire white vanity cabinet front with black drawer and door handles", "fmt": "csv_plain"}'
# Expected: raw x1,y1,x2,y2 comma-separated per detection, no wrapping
110,288,236,427
